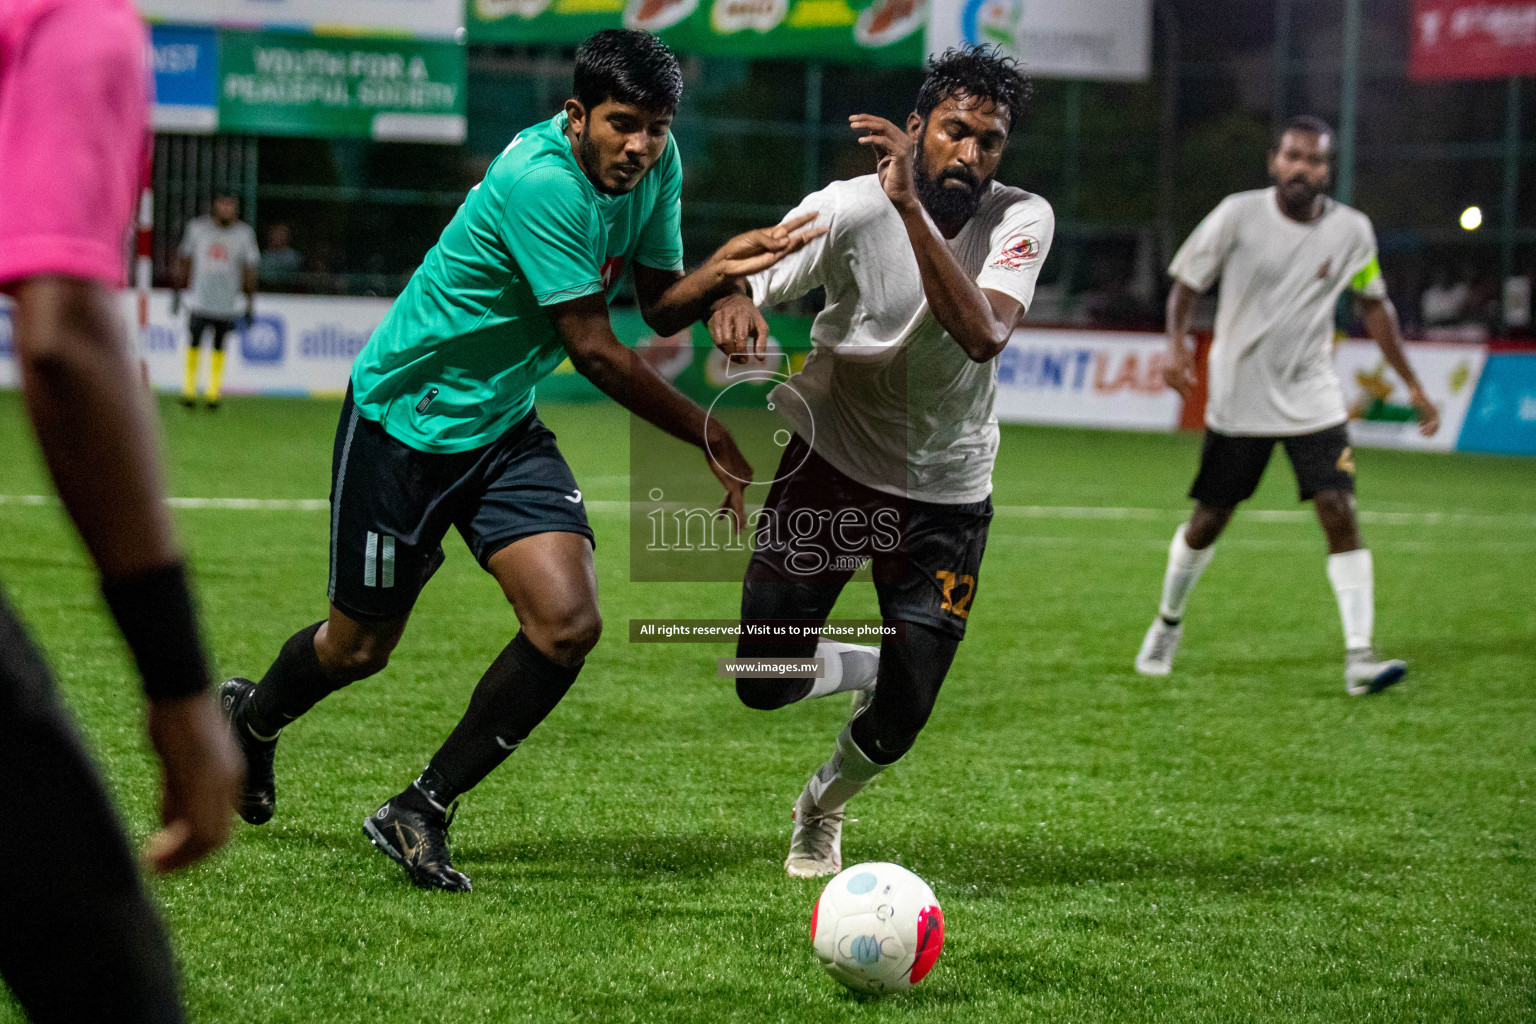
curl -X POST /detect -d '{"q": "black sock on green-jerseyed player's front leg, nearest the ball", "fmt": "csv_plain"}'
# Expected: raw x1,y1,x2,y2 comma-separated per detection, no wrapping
418,633,581,808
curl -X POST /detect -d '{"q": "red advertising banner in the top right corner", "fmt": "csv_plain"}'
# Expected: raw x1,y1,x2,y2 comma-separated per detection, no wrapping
1409,0,1536,80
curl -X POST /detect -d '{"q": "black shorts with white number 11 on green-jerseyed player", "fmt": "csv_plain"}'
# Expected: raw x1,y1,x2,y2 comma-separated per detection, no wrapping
330,388,593,620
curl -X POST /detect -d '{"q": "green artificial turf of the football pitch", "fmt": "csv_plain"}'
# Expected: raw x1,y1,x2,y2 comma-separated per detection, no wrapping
0,395,1536,1024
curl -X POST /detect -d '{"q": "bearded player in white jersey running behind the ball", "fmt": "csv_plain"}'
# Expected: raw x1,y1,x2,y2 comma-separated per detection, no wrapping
710,48,1055,877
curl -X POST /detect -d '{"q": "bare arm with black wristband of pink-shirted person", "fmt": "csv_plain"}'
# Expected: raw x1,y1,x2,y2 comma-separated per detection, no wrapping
15,278,241,870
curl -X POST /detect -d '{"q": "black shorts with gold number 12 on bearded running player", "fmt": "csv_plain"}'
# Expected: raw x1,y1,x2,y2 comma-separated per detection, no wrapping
746,434,992,639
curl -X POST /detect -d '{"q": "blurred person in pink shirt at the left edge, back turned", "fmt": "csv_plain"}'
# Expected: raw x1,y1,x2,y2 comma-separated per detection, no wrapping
0,0,241,1022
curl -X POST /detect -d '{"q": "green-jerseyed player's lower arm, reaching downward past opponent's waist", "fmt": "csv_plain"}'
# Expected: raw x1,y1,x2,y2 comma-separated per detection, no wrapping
545,293,753,531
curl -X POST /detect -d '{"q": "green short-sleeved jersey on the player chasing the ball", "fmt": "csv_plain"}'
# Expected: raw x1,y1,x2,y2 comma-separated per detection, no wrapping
352,114,682,451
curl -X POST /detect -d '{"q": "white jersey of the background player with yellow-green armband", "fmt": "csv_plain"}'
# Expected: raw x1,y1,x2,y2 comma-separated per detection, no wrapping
1167,187,1387,436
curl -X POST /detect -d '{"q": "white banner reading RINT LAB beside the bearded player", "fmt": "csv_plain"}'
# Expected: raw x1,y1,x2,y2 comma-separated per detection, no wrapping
997,329,1184,430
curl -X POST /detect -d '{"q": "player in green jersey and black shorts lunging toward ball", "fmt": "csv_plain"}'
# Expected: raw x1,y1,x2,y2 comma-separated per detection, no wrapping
221,29,820,890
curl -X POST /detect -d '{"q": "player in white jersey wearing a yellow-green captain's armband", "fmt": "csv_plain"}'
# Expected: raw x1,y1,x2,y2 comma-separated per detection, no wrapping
1137,117,1439,695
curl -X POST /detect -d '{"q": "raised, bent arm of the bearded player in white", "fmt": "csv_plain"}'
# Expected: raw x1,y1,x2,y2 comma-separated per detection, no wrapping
848,114,1025,362
